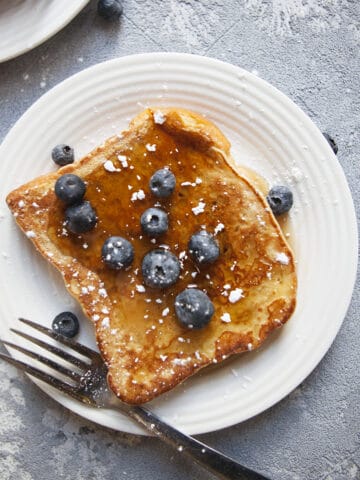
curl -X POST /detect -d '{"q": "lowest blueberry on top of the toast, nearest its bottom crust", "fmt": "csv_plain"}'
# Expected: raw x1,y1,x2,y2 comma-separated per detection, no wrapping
175,288,215,328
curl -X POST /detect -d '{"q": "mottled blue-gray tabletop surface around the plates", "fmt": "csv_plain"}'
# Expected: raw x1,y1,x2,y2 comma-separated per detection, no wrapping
0,0,360,480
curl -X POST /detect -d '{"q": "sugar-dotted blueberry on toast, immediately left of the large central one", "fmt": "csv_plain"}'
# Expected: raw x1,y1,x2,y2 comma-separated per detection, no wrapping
101,237,134,270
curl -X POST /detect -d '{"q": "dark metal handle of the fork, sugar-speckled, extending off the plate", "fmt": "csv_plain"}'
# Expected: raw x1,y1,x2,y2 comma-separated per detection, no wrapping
121,406,270,480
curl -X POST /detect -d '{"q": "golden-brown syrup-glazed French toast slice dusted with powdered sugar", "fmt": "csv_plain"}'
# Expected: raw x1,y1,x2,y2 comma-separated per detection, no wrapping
7,108,296,404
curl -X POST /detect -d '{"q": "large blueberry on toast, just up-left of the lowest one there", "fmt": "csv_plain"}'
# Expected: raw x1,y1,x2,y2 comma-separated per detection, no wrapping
141,249,180,288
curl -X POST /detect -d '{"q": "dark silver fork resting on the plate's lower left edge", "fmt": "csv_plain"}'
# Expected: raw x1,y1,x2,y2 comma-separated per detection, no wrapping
0,318,270,480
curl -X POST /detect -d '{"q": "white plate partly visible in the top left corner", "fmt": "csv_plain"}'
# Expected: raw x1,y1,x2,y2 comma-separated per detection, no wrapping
0,0,89,62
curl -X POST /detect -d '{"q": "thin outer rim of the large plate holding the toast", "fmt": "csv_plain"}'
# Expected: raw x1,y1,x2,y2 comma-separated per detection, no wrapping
0,51,358,435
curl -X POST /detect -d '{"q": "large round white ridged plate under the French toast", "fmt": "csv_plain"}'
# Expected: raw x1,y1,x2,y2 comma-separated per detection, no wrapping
0,53,357,434
